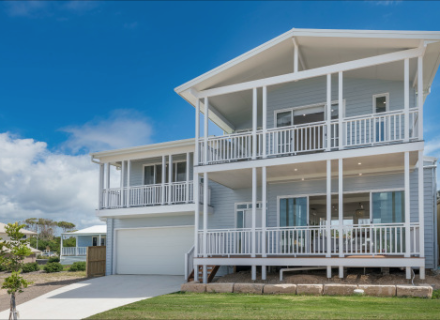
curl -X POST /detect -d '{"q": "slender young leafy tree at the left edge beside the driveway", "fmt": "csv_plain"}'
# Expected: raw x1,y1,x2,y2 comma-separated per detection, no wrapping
1,222,32,320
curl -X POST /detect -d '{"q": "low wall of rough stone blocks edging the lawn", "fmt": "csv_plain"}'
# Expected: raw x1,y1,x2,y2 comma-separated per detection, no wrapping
181,282,433,298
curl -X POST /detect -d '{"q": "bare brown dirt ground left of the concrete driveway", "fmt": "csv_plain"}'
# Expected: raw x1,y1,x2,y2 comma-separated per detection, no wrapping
0,271,86,311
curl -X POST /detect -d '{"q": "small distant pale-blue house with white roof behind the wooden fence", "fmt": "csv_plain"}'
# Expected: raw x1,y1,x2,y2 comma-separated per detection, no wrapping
60,225,107,264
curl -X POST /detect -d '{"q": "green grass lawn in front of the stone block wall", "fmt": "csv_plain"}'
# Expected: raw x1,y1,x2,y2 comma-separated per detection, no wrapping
88,292,440,319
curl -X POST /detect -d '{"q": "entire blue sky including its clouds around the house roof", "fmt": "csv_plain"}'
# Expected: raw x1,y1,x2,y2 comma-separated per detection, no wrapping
0,1,440,228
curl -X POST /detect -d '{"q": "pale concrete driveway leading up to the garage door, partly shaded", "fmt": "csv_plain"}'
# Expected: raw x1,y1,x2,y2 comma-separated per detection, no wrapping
0,275,184,319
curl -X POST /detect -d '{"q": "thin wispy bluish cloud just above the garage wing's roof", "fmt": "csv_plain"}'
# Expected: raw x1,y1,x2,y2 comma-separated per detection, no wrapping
62,110,152,153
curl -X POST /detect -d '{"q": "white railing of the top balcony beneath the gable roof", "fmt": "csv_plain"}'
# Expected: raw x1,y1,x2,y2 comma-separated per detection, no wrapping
199,108,419,165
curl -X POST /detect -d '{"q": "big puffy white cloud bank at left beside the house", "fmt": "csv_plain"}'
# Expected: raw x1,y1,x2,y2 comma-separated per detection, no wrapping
0,133,119,232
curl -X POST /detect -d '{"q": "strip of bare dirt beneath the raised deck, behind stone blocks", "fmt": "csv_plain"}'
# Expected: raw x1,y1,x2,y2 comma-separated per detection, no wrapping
215,269,440,289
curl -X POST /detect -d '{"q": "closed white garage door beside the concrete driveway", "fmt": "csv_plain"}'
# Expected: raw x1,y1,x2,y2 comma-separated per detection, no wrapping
116,227,194,275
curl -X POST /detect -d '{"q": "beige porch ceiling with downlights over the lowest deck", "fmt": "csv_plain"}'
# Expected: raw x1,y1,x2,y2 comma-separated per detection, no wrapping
209,152,418,189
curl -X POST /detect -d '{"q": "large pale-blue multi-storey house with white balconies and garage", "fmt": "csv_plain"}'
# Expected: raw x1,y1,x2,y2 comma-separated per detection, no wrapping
92,29,440,282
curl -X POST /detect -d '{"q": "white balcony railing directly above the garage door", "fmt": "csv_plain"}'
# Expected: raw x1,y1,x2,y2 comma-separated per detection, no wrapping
101,181,211,209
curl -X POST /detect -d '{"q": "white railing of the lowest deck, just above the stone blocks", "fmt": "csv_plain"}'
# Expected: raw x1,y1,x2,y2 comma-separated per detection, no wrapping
198,223,419,257
